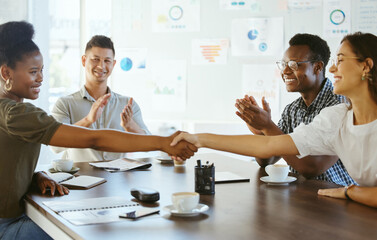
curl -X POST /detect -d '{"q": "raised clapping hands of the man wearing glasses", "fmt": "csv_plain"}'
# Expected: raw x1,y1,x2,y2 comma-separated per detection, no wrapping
235,95,273,135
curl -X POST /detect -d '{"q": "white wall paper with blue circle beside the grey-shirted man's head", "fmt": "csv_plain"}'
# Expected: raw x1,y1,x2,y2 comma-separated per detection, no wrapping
115,48,148,74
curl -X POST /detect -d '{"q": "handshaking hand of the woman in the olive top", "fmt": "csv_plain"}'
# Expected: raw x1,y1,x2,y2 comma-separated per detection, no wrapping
162,131,198,160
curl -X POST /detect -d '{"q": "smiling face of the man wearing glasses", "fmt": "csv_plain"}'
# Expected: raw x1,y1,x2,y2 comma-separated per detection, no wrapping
281,45,320,93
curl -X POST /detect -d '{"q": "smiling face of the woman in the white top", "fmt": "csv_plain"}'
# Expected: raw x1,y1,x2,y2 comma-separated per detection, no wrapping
329,41,367,98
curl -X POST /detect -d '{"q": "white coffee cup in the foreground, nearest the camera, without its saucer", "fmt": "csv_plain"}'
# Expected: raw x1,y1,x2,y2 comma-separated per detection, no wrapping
171,192,199,212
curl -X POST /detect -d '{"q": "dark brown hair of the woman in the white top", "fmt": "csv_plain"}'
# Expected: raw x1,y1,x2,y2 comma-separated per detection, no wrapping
341,32,377,103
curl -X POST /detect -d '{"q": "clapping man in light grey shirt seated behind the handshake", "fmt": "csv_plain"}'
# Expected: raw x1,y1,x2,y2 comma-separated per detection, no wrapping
51,35,150,162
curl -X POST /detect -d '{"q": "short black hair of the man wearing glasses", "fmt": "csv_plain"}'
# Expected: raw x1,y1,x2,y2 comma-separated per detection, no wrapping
289,33,331,74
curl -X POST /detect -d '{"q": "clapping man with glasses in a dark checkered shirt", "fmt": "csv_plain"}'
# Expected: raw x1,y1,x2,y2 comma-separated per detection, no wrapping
236,34,356,186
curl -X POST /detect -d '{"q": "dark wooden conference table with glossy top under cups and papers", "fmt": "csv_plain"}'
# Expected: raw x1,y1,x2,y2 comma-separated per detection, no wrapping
26,153,377,240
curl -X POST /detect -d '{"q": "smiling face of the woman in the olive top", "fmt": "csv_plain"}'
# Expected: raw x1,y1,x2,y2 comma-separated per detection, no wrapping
7,51,43,102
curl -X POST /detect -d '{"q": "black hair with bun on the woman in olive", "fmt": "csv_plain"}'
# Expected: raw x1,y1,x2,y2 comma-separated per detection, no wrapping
0,21,39,68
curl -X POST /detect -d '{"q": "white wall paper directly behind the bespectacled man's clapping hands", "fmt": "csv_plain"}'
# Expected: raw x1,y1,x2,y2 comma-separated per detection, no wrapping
242,64,281,123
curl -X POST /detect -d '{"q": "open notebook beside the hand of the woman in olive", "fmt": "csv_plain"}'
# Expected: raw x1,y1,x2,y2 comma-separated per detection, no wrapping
49,172,106,189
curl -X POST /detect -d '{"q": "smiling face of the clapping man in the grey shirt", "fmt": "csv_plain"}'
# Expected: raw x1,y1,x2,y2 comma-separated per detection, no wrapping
82,47,115,83
